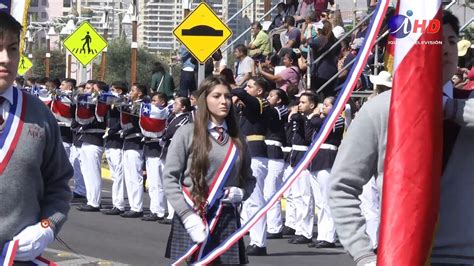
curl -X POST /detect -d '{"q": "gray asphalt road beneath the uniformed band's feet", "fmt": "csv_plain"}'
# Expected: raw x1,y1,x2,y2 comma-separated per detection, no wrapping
45,180,354,266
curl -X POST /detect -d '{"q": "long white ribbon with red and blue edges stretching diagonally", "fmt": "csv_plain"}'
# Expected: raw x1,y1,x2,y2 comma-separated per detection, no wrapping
191,0,389,265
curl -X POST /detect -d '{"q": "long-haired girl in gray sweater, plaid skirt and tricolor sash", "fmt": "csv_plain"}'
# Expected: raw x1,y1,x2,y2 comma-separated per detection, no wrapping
163,77,255,264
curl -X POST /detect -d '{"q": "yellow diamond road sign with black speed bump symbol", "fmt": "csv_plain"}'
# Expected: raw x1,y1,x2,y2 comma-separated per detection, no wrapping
173,3,232,63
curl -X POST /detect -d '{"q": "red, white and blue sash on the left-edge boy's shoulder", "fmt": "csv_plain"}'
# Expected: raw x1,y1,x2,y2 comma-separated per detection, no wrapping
0,88,27,175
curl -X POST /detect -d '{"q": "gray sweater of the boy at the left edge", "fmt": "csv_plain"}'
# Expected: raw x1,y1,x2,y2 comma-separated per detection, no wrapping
0,92,73,247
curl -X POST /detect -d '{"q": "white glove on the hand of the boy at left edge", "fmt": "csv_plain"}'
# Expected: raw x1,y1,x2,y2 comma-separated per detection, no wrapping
13,223,54,261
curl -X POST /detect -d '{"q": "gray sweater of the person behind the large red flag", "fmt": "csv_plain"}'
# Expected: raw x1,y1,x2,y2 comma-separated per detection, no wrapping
328,91,474,265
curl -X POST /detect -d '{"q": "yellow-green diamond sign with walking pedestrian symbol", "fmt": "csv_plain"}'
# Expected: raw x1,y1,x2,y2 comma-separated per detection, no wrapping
64,21,107,66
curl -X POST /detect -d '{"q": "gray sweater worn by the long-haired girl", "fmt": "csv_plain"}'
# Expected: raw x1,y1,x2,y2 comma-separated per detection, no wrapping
163,123,256,220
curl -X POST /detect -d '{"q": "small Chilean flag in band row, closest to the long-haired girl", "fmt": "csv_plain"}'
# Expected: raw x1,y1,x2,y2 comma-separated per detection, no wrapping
140,103,169,138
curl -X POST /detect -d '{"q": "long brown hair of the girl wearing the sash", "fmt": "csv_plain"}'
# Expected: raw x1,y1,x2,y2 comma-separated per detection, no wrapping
190,77,245,207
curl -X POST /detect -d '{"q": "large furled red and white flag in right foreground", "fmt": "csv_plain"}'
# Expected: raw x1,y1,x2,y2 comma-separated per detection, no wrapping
377,0,443,266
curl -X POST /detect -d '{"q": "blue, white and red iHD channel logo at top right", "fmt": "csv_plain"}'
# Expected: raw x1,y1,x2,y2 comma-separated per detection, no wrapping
388,10,441,39
